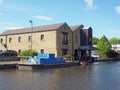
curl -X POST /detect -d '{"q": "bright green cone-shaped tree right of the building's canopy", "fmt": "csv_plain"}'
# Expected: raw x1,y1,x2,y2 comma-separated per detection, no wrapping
97,35,111,58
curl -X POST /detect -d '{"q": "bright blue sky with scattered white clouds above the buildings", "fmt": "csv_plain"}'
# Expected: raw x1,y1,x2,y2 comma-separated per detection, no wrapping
0,0,120,39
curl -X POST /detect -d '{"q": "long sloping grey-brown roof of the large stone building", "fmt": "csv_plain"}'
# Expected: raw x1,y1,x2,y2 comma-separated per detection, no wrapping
0,23,66,36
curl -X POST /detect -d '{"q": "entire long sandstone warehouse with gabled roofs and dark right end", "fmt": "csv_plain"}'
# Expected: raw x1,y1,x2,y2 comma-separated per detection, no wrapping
0,23,94,59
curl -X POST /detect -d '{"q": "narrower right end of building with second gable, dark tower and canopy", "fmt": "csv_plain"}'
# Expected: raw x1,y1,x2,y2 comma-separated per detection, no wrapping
71,25,96,60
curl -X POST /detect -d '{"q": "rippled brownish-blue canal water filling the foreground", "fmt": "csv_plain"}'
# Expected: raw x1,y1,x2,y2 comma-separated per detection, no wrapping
0,62,120,90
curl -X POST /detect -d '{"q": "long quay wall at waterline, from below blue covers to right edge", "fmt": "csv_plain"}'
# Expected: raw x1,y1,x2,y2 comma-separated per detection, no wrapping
17,58,120,70
